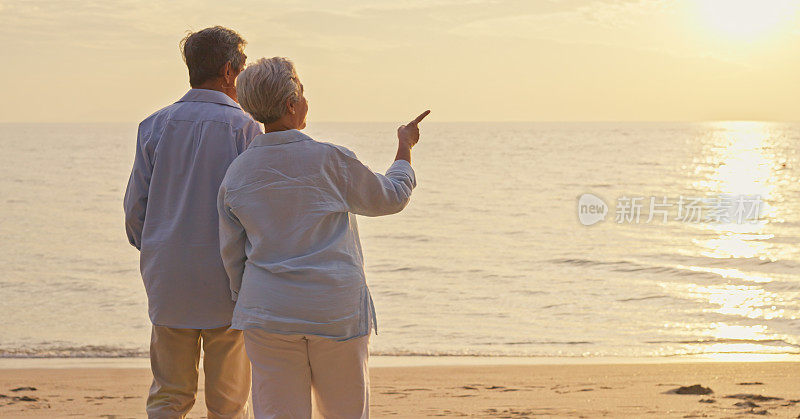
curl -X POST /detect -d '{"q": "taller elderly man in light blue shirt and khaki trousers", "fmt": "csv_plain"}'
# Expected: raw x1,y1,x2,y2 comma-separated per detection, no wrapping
124,26,261,418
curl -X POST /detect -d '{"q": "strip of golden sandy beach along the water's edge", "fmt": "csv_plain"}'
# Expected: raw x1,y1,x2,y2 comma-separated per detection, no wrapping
0,362,800,418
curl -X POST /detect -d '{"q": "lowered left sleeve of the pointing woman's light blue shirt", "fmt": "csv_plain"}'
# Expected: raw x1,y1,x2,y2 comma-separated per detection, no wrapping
217,182,247,301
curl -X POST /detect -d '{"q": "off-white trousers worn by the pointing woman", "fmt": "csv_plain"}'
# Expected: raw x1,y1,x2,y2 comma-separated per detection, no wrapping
244,329,369,419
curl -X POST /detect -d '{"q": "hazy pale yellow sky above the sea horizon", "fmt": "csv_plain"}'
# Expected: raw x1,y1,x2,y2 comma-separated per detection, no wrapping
0,0,800,122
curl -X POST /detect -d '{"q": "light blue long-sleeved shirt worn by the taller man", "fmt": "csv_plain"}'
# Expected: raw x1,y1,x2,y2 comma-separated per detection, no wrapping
124,89,262,329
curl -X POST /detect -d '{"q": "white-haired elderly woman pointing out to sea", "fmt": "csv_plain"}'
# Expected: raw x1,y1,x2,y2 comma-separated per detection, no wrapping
218,57,429,418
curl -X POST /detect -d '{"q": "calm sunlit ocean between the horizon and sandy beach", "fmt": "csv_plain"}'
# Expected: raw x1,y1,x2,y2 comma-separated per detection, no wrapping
0,121,800,360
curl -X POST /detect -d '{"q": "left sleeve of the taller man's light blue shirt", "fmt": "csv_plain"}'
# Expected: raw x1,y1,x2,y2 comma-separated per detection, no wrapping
123,126,153,250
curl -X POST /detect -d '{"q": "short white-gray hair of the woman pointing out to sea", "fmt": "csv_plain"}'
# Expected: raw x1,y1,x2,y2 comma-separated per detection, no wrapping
236,57,302,124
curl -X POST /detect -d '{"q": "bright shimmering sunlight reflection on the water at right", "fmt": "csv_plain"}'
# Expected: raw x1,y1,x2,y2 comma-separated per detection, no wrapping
670,122,798,361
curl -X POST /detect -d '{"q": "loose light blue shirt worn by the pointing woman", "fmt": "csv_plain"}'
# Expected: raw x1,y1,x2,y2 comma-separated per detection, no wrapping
217,130,416,340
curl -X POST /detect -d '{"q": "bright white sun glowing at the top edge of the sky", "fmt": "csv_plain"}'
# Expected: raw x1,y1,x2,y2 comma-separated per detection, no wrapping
697,0,799,40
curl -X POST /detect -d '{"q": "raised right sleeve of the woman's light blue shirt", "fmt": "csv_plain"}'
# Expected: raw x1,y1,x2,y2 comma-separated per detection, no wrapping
337,147,417,217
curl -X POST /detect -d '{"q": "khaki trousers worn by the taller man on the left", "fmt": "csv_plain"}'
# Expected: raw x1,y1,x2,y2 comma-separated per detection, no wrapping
147,325,250,419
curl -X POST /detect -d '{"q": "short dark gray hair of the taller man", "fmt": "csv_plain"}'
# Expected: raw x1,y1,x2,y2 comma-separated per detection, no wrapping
180,26,247,87
